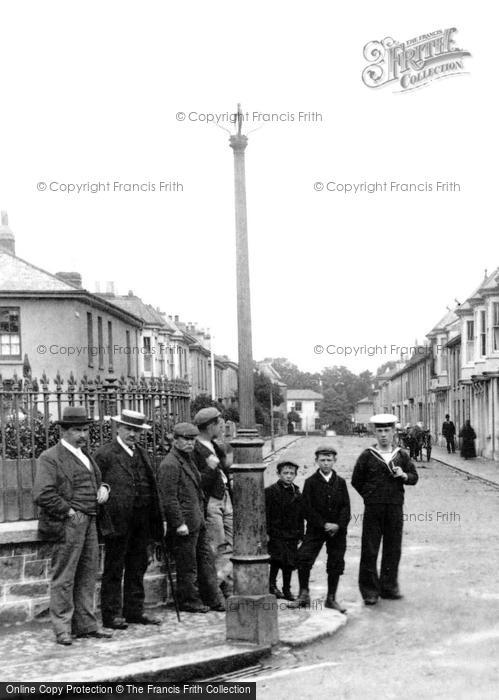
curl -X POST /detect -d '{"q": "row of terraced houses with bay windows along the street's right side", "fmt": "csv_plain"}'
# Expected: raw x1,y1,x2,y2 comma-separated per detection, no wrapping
374,268,499,459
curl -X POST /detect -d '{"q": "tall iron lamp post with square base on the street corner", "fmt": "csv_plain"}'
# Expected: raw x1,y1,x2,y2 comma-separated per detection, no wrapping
226,105,278,644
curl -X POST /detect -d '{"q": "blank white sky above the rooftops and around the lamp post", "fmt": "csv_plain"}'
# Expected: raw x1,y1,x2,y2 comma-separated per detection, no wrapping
0,0,492,372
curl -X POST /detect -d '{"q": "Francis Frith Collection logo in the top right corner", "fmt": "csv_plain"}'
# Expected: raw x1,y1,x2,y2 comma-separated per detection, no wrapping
362,28,471,92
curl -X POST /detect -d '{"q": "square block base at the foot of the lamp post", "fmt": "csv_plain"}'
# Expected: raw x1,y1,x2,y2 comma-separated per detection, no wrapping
225,593,279,645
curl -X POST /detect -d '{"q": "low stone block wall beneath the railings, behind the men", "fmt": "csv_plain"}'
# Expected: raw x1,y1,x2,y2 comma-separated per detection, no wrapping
0,520,170,626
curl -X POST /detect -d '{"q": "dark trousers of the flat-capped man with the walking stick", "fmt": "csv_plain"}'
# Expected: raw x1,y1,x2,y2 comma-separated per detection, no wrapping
173,527,221,607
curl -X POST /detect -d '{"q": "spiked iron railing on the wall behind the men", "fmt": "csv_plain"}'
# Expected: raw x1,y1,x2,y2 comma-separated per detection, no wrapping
0,373,190,522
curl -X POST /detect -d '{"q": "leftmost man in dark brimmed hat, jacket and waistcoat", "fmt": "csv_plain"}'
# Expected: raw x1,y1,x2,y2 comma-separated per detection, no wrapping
33,406,111,646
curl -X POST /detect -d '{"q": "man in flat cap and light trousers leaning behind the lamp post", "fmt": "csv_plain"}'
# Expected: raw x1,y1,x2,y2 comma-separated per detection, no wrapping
192,406,233,596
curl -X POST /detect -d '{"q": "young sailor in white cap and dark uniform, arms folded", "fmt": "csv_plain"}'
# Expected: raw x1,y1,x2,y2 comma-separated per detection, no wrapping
352,413,418,605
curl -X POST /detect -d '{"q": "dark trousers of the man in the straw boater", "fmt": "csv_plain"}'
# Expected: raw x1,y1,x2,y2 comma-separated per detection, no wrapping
101,508,150,623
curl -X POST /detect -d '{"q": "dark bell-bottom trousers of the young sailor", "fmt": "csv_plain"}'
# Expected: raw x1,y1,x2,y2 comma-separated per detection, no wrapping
359,503,403,599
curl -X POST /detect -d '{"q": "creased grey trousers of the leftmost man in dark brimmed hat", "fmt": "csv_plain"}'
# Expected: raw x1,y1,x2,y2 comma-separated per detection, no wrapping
50,511,99,635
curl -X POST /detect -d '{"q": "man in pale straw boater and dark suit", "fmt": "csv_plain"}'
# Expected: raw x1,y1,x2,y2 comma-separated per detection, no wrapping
94,409,163,630
